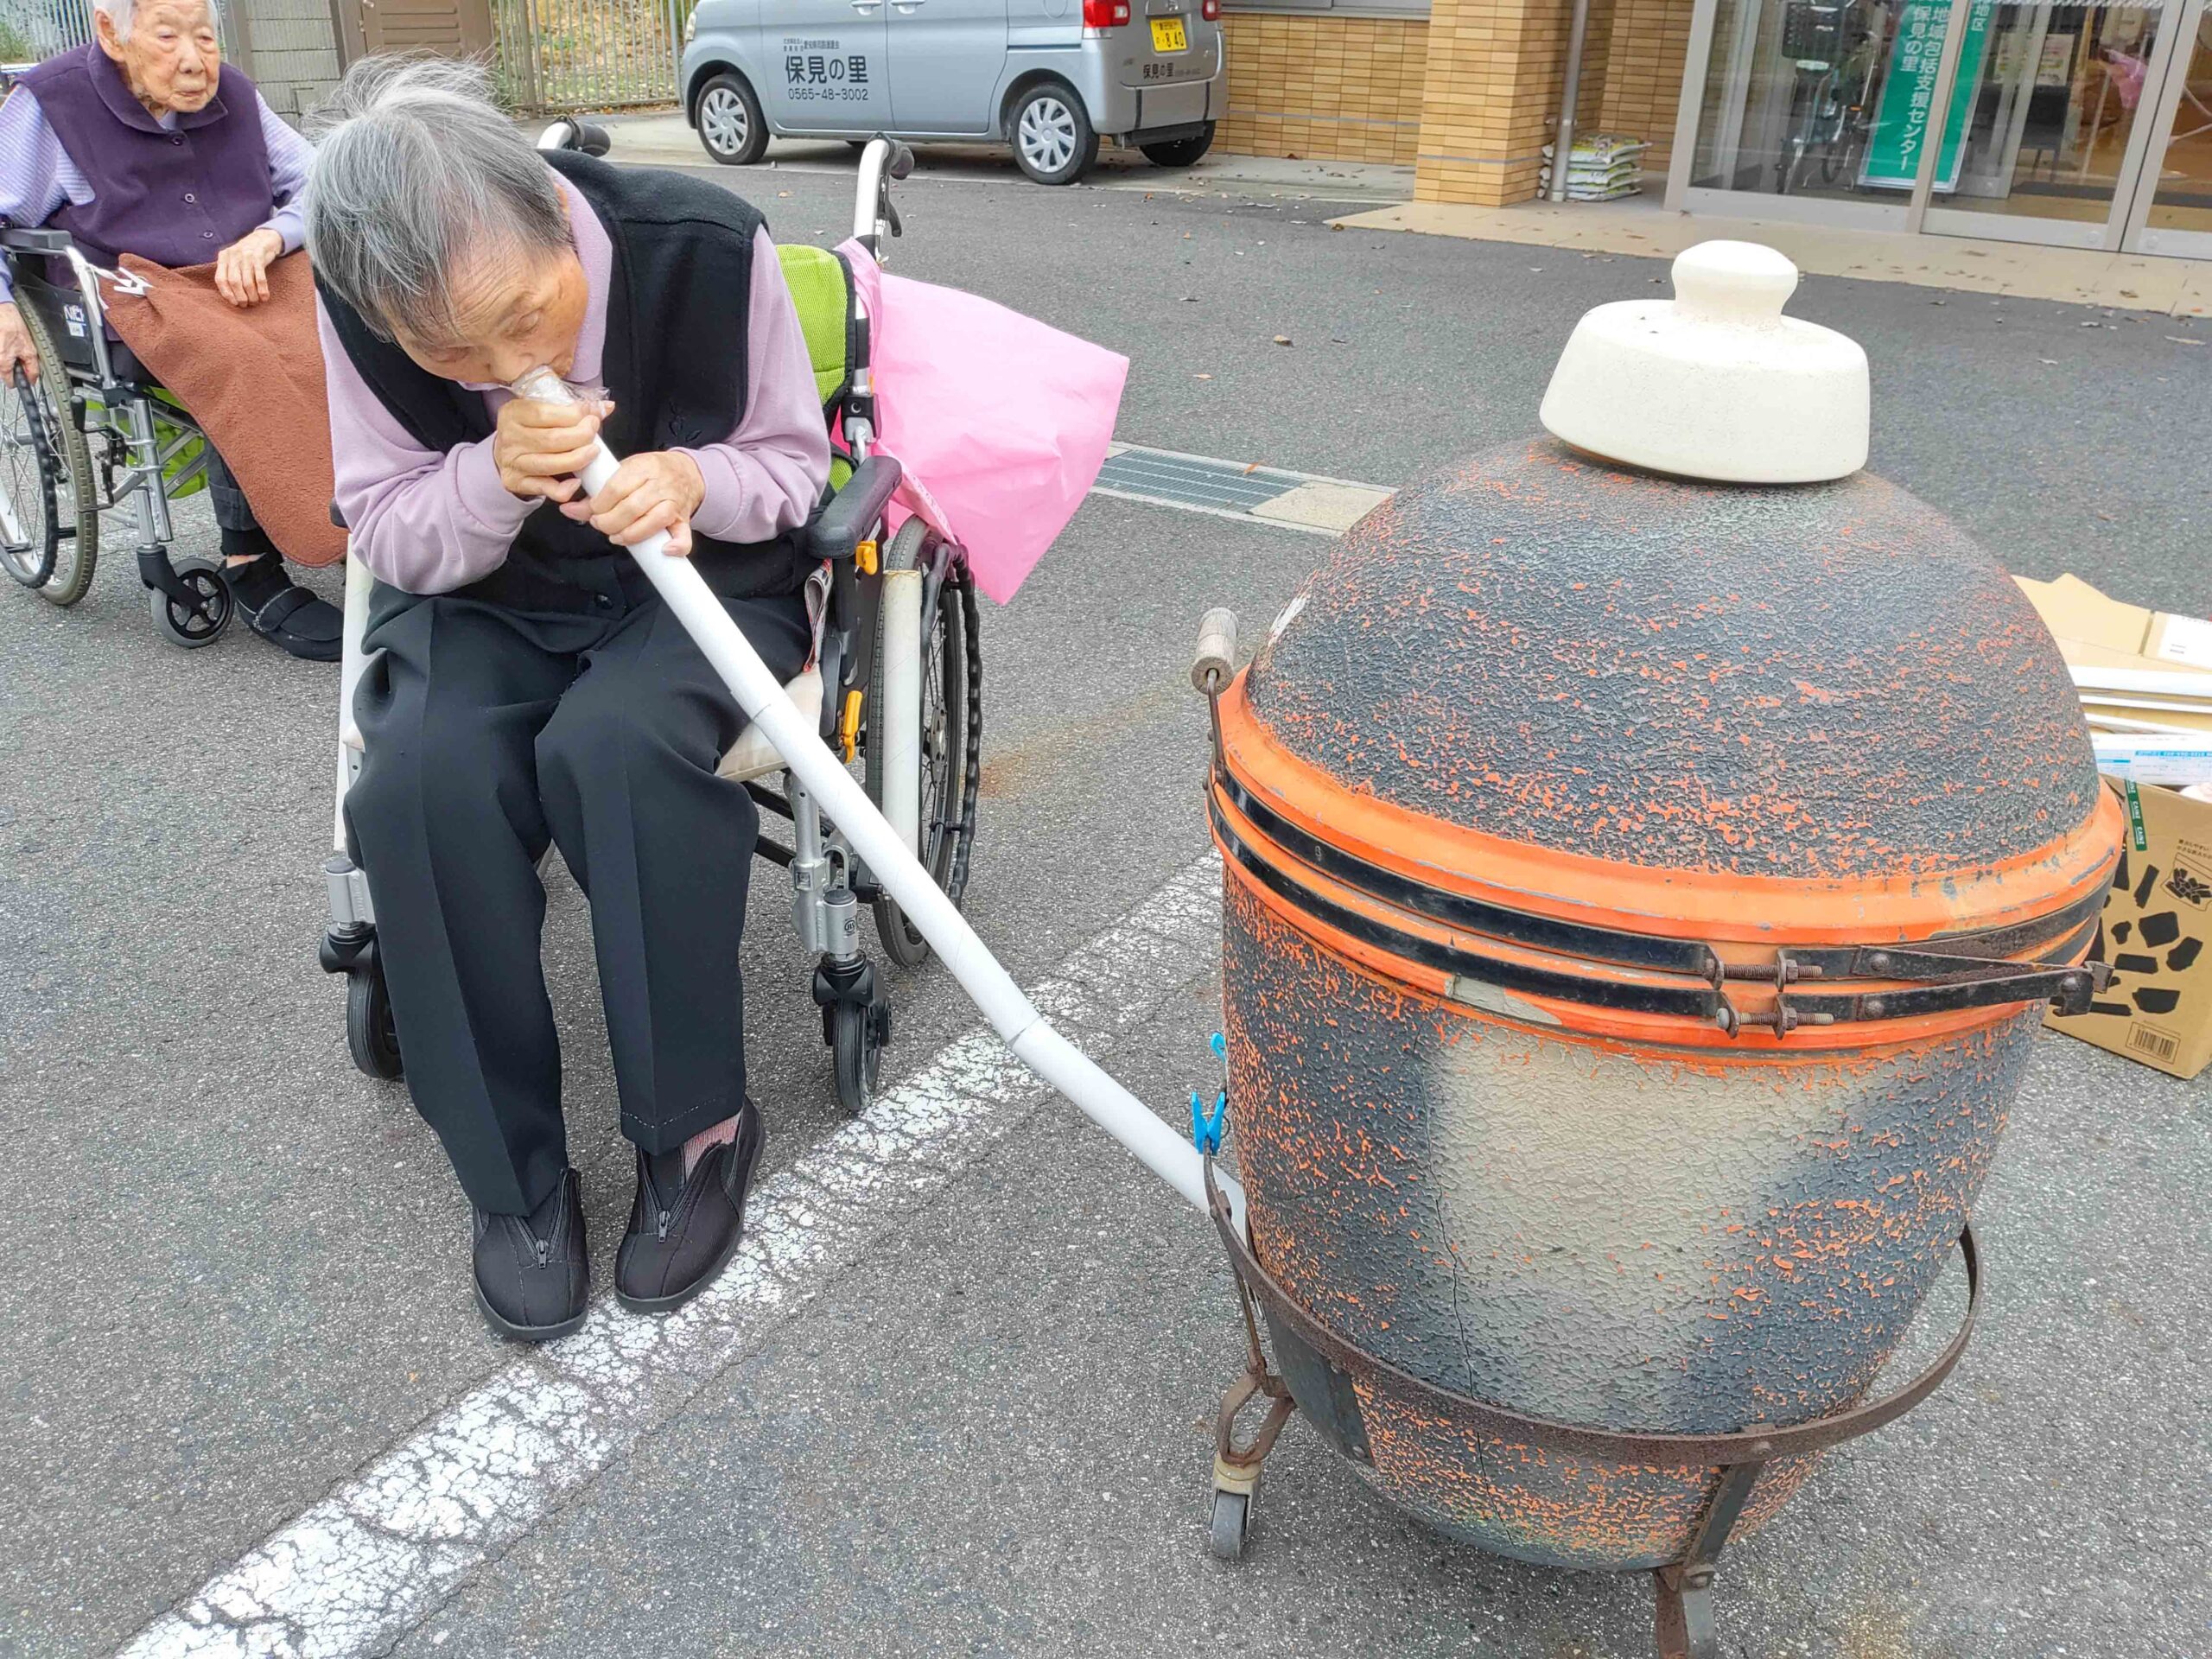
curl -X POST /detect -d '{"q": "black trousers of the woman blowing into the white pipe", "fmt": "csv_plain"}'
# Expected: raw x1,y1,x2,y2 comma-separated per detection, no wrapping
345,584,810,1214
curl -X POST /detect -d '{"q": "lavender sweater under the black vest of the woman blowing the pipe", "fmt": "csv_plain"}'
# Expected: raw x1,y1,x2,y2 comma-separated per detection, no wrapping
316,179,830,593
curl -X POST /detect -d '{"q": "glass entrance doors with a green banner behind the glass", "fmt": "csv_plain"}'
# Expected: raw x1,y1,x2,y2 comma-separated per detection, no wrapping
1668,0,2212,259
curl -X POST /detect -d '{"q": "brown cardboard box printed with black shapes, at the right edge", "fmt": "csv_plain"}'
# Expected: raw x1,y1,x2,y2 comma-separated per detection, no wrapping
2044,779,2212,1077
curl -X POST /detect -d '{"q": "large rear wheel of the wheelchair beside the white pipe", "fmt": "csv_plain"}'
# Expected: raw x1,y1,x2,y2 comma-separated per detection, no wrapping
862,518,980,969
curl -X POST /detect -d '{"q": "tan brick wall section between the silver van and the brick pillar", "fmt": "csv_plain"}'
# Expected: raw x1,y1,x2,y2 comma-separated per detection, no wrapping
1214,11,1429,166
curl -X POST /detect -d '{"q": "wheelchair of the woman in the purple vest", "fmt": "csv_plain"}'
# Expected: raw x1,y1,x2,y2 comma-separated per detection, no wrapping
0,230,232,651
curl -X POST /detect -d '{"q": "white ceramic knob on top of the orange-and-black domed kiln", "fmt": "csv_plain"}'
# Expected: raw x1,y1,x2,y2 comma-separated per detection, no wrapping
1541,241,1869,485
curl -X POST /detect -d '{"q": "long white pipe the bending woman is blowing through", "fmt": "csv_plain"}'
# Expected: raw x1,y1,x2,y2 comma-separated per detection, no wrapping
513,370,1245,1232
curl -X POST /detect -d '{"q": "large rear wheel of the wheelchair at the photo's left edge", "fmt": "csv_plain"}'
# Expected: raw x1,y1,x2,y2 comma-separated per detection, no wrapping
0,305,99,606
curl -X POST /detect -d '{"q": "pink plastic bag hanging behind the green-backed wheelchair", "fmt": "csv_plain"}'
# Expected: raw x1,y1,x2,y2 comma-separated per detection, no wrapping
838,241,1128,604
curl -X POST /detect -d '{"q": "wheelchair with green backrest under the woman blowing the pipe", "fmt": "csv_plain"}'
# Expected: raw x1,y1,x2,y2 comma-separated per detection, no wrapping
321,122,982,1113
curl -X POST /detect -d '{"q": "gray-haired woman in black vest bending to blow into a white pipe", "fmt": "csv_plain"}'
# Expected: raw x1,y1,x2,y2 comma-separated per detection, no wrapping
308,60,830,1340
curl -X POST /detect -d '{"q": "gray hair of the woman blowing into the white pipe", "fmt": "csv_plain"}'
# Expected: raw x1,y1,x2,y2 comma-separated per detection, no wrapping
308,55,570,340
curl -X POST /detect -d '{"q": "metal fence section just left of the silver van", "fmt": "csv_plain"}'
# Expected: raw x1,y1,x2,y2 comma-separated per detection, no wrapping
495,0,696,115
